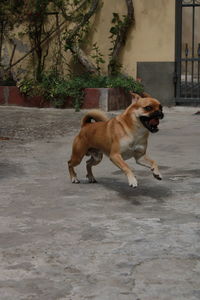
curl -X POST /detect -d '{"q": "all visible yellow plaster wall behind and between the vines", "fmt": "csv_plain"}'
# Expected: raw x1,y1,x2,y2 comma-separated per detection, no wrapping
1,0,175,81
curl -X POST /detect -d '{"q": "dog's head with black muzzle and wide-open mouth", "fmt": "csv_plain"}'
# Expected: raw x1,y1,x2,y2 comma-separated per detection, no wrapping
131,93,164,133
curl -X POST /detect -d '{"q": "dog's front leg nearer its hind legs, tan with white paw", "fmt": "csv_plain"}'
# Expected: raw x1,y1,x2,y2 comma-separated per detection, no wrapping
110,153,137,188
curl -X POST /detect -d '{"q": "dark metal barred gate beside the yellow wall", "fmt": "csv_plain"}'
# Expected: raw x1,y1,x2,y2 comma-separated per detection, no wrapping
174,0,200,105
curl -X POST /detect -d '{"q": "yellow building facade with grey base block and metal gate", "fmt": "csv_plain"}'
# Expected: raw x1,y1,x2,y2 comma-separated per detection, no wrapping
3,0,200,105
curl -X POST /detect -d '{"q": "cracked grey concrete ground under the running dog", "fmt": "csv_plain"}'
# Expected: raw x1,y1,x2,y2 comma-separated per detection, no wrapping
0,107,200,300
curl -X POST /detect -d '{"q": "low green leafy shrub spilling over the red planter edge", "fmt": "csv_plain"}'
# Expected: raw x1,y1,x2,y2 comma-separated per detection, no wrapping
18,71,144,111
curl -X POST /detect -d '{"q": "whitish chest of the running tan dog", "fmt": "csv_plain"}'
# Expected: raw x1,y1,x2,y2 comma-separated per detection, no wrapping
120,130,146,160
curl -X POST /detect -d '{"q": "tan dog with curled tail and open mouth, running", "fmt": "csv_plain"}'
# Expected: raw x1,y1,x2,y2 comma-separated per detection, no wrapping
68,93,164,188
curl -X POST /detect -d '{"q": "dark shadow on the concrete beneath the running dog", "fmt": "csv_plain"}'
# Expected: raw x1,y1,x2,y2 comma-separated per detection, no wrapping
98,173,172,205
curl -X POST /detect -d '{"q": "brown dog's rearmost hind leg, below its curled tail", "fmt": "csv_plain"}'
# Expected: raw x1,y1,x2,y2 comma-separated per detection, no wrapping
68,138,87,183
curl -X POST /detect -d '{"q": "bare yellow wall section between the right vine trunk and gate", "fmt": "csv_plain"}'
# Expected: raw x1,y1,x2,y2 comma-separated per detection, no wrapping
124,0,175,74
